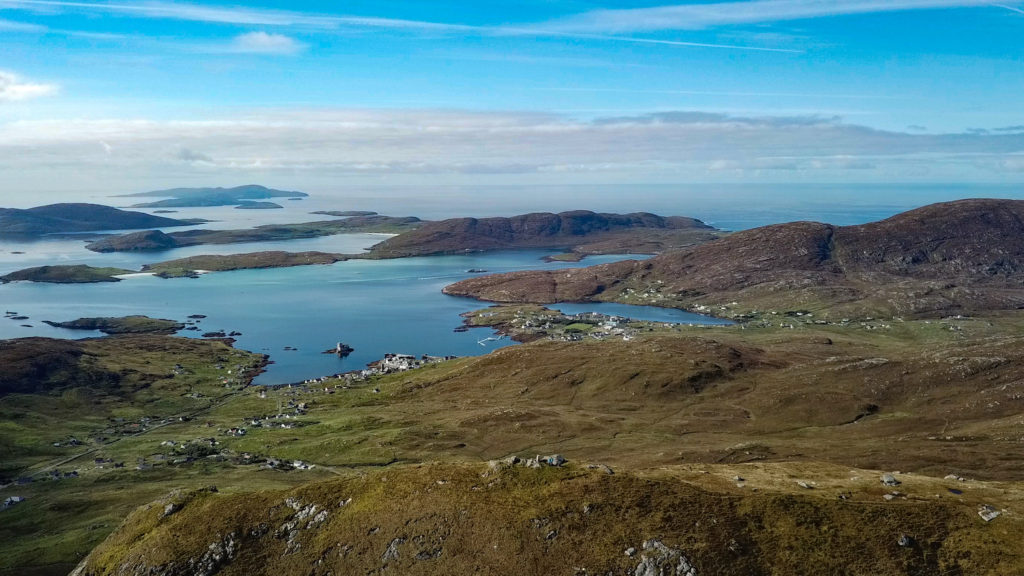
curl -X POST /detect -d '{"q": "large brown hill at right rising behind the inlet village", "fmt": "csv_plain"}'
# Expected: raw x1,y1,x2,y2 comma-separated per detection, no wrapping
445,200,1024,317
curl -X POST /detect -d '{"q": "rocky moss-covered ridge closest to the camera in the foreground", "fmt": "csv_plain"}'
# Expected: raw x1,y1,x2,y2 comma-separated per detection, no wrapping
73,464,1024,576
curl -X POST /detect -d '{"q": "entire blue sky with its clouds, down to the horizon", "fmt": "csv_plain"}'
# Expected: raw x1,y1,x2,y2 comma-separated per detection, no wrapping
0,0,1024,194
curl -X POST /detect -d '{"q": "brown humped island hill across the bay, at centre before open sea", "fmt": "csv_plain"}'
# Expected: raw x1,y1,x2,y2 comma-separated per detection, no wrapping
371,210,719,258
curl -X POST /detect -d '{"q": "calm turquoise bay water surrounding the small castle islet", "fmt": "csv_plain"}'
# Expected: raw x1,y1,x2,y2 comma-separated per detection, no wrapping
0,251,716,384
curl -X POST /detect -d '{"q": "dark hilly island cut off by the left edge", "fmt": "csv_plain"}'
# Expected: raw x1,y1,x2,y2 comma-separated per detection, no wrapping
0,203,198,236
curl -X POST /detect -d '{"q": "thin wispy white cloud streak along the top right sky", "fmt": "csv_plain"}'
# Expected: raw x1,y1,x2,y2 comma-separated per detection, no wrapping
548,0,1019,34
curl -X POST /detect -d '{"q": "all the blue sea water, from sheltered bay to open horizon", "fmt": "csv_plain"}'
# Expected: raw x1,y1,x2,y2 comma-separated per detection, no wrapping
6,184,1024,384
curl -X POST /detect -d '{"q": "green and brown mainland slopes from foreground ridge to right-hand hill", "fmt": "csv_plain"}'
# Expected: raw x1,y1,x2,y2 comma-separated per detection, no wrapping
9,203,1024,576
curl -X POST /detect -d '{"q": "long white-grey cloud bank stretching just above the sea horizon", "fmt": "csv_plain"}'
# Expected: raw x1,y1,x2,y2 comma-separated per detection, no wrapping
0,110,1024,190
